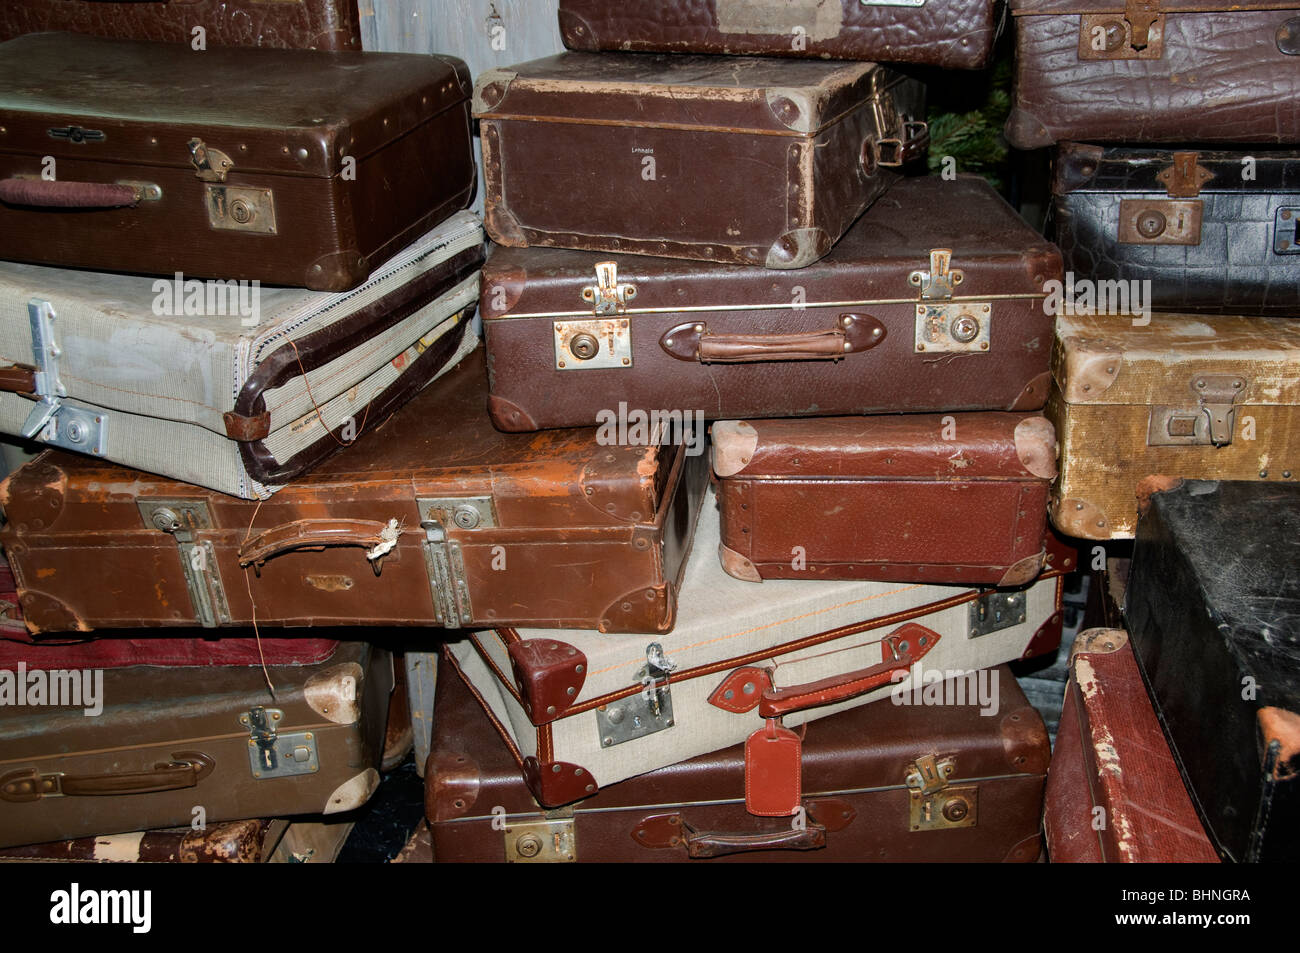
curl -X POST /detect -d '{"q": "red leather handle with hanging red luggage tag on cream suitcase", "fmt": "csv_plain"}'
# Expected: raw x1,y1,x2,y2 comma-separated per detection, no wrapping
709,623,940,818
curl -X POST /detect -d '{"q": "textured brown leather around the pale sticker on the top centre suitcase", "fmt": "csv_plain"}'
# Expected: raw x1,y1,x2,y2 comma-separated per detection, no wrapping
560,0,997,69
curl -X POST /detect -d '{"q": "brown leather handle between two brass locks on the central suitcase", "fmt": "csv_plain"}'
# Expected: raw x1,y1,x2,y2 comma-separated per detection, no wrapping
659,313,885,364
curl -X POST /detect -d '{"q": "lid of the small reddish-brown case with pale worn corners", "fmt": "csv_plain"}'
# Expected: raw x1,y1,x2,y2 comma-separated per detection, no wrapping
712,412,1057,482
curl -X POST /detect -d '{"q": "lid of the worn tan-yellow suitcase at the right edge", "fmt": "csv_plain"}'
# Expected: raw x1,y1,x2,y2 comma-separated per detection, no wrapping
1052,310,1300,407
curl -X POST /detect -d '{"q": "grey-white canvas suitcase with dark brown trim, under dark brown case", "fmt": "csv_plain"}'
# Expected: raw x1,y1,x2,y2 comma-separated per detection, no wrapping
0,212,484,499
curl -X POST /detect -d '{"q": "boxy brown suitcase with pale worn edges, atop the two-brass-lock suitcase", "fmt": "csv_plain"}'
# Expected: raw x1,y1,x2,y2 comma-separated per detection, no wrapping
473,53,930,268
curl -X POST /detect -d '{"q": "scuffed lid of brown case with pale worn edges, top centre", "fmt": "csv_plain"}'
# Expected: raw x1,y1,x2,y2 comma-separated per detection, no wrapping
473,52,902,135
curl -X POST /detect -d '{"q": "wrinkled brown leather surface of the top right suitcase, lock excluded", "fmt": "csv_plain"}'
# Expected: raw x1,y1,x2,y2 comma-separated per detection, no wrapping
1006,10,1300,150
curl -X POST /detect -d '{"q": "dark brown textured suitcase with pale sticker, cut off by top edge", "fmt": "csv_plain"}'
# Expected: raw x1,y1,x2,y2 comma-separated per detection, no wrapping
560,0,998,69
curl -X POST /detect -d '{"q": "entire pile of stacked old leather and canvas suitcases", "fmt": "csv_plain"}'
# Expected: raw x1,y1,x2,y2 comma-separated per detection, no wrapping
0,0,1284,862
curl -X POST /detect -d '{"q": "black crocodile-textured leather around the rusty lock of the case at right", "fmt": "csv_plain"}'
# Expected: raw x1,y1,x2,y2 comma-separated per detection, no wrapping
1052,148,1300,310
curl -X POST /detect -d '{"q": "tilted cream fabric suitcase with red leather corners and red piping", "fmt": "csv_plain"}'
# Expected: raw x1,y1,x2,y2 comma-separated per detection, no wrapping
445,494,1075,807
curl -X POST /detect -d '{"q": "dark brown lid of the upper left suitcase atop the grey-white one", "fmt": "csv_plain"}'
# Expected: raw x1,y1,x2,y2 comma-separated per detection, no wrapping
0,33,469,176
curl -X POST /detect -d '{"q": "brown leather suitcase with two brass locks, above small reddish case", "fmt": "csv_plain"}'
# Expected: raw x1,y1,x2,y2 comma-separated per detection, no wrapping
480,176,1062,430
